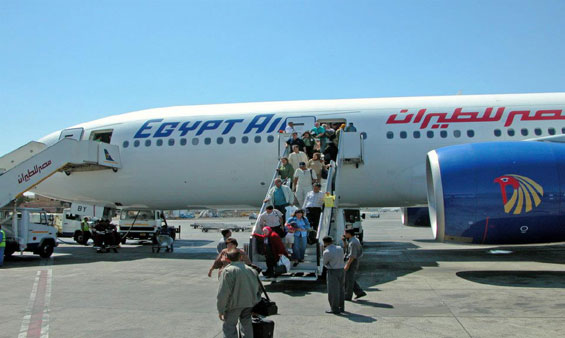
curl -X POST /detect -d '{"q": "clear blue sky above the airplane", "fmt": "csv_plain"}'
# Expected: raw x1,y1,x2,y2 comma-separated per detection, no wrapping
0,0,565,155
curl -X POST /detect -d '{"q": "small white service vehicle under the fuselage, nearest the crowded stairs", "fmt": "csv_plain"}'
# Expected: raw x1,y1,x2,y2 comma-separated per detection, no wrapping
118,209,163,243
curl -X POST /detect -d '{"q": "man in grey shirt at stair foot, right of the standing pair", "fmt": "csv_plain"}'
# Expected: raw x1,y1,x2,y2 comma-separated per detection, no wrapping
344,229,367,300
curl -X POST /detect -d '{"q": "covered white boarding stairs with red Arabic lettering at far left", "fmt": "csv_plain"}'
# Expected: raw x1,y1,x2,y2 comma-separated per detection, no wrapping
0,138,121,207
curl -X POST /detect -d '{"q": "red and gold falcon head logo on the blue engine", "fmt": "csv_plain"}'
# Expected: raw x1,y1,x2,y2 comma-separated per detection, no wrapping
494,174,543,215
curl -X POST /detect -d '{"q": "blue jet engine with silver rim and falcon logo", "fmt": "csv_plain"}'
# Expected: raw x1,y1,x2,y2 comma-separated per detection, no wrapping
426,142,565,244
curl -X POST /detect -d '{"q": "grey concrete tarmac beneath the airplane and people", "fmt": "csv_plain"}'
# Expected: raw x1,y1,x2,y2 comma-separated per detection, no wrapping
0,212,565,338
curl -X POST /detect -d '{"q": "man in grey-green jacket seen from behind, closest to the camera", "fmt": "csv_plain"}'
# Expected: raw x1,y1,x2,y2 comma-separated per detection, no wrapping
217,249,261,338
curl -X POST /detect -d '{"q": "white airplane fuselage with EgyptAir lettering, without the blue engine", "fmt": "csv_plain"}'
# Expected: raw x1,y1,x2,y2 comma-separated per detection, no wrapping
34,93,565,209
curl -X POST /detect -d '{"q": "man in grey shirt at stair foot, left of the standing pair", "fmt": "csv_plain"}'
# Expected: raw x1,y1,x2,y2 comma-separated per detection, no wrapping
323,236,345,315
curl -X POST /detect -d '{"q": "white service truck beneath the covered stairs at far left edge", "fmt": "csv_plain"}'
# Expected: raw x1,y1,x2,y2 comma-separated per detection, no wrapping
0,208,57,258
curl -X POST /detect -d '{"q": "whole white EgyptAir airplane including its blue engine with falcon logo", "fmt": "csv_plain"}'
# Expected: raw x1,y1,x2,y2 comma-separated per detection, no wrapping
11,93,565,244
